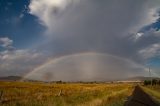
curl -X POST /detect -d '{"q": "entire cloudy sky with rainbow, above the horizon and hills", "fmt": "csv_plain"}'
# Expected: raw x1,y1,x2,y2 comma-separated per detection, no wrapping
0,0,160,81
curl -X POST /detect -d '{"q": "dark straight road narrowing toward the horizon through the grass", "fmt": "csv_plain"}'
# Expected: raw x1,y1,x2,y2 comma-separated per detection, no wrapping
125,86,159,106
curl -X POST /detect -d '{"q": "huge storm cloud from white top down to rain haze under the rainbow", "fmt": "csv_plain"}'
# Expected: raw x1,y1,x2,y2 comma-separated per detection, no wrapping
0,0,160,81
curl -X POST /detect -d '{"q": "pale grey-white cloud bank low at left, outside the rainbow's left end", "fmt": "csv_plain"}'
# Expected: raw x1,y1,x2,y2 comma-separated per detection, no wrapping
0,50,46,76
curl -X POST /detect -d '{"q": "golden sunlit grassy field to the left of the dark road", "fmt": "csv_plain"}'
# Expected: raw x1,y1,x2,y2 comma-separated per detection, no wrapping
0,82,134,106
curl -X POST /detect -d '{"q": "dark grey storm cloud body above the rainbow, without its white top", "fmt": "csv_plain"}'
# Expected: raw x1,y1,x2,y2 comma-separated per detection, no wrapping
33,0,159,62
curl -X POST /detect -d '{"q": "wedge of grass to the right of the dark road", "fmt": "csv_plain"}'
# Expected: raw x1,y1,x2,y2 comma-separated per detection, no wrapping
142,85,160,103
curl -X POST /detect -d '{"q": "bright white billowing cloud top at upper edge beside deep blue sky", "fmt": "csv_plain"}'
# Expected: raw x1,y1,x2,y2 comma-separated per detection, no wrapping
29,0,77,28
